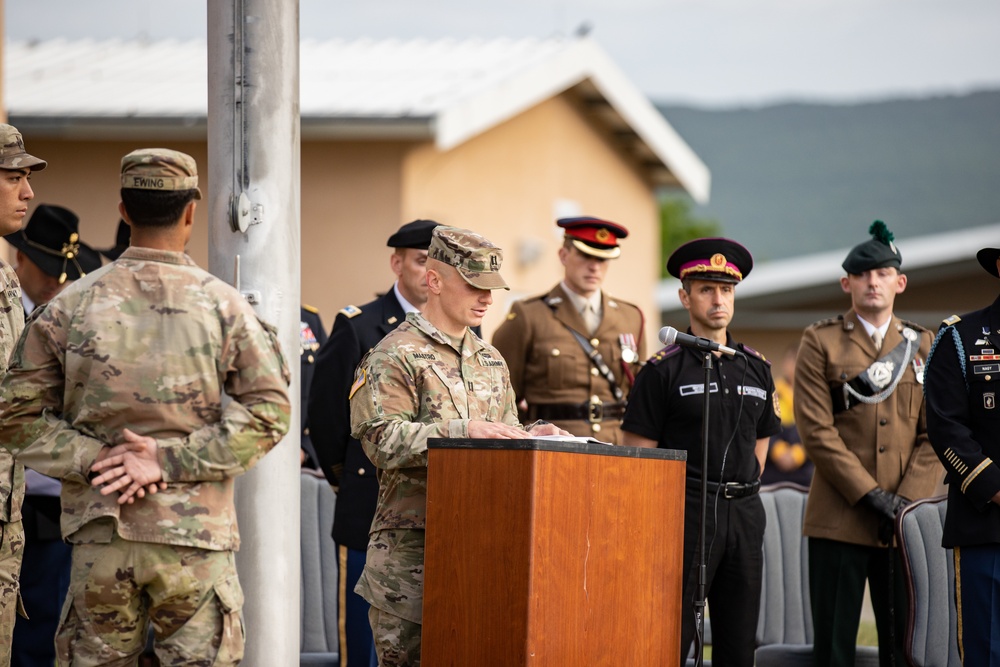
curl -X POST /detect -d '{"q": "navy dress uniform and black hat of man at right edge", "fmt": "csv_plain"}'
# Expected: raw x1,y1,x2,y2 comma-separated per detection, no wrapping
924,248,1000,665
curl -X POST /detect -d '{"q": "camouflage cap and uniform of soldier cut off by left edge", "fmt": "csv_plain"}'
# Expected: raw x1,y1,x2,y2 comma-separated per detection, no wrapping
0,124,47,665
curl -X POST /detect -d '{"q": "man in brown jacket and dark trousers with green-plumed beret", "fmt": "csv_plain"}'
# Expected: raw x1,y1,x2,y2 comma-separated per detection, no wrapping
795,221,944,667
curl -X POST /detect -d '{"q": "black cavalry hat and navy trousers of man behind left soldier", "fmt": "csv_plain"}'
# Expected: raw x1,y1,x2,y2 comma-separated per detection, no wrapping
4,204,101,667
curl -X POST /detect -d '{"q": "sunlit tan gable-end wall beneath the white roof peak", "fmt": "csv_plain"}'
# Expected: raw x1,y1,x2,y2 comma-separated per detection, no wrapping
402,95,659,350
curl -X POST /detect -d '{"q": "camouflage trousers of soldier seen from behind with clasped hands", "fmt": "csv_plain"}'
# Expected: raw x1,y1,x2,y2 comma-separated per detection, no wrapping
56,535,243,667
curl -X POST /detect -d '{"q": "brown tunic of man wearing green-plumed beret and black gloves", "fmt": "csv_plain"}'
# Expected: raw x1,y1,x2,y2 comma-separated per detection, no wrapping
795,310,944,547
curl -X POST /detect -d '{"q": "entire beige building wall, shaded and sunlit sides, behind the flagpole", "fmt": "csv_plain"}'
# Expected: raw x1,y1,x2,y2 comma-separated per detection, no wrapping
2,96,659,350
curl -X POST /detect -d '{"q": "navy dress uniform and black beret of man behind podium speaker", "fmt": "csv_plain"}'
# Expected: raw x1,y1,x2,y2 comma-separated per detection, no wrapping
308,220,438,667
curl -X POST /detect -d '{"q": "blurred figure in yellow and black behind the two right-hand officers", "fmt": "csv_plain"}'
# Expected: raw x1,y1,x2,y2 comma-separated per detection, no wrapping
760,343,813,486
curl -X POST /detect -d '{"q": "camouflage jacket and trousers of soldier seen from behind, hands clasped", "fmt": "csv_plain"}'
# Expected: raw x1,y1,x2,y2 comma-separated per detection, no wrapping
0,150,291,665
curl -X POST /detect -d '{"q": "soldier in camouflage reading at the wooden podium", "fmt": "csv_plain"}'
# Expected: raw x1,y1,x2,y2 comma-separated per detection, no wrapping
350,227,568,667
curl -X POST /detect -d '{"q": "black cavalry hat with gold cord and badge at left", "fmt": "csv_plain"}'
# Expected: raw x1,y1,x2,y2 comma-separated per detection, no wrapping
4,204,101,284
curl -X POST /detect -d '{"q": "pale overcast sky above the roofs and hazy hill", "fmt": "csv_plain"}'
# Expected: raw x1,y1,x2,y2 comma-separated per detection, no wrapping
4,0,1000,106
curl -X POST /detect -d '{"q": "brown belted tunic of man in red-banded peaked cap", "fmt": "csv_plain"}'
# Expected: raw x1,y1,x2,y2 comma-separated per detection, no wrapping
493,285,646,444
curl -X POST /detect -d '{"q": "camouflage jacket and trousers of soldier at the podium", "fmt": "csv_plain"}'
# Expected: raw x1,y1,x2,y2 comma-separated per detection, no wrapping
351,228,520,665
